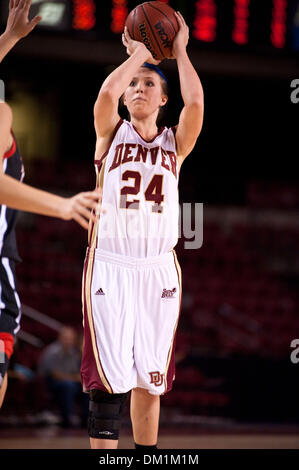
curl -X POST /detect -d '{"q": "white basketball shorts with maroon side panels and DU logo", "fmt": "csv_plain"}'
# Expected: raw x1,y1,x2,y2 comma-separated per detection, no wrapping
81,248,182,395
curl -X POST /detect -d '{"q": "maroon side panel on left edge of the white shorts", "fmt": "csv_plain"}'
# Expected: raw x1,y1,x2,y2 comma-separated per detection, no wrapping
81,249,112,392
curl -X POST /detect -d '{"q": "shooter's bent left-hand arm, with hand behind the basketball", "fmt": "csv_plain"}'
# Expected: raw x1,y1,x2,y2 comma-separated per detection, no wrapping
94,28,158,138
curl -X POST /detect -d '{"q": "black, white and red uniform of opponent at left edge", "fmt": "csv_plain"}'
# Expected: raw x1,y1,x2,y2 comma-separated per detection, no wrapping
0,132,24,386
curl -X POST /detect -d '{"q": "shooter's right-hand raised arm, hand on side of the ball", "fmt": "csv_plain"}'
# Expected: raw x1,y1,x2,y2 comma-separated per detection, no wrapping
173,13,204,161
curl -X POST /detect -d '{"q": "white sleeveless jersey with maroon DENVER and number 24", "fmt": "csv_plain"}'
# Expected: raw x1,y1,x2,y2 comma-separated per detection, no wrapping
89,120,179,258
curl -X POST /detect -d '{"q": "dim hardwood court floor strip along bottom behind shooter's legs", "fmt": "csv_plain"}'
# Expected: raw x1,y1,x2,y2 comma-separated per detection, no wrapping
0,428,299,449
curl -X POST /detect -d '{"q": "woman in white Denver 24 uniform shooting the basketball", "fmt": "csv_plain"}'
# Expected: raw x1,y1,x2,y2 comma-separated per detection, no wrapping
81,13,203,451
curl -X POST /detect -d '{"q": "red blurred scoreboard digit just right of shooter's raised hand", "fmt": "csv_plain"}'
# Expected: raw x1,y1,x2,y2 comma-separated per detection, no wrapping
192,0,217,42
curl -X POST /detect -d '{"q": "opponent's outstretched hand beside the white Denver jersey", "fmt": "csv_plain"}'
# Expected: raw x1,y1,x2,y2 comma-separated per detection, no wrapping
60,190,105,230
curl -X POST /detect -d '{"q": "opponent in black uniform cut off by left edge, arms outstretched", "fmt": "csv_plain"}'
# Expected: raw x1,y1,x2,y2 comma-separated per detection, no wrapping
0,0,101,408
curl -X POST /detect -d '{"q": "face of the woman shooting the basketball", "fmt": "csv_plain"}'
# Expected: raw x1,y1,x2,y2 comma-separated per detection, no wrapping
124,67,167,119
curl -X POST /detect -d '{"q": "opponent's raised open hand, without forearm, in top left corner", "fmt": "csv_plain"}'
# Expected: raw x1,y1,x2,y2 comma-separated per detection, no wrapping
5,0,42,39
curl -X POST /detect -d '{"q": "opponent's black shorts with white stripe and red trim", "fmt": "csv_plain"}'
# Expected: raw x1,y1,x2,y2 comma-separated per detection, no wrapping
0,257,21,386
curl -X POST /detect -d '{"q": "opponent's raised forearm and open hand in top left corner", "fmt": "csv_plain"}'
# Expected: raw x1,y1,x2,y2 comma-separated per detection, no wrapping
0,0,42,62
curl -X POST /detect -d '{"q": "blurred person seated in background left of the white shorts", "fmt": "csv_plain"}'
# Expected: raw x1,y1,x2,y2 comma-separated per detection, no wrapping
38,326,89,428
